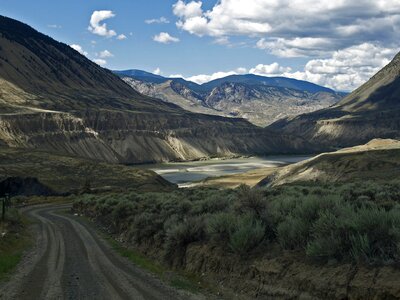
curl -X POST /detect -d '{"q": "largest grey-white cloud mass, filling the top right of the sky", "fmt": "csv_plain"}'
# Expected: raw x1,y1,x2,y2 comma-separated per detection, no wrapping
173,0,400,57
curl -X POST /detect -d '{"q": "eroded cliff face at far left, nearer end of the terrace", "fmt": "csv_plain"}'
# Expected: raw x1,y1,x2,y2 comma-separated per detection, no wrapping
0,112,119,163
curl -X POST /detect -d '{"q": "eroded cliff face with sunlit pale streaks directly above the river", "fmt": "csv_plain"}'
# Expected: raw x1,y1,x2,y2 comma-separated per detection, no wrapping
80,112,306,163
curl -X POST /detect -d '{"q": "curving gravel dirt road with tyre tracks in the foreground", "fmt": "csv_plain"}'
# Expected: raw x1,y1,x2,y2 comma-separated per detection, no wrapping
0,205,191,300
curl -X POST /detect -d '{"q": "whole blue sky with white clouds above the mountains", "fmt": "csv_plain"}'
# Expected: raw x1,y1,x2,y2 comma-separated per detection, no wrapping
0,0,400,91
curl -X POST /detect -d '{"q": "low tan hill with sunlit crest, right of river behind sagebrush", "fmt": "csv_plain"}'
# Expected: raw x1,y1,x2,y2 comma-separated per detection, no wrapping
258,139,400,186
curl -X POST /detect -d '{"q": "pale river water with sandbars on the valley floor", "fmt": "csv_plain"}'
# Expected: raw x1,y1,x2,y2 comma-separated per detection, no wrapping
142,155,310,185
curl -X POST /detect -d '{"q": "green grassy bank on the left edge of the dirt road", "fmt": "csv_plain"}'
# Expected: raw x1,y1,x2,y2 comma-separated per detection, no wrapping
0,209,32,281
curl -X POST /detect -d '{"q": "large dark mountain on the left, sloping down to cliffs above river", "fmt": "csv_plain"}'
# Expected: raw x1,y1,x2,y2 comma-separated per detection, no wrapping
0,17,309,164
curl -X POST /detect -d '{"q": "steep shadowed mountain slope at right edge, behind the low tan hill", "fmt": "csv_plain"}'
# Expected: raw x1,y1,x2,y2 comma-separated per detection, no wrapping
269,53,400,148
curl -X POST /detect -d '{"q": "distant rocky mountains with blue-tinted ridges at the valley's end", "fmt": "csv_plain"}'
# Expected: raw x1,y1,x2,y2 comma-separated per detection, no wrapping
114,70,345,126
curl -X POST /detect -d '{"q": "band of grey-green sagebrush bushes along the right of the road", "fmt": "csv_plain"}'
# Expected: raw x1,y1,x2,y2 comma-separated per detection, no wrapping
74,182,400,263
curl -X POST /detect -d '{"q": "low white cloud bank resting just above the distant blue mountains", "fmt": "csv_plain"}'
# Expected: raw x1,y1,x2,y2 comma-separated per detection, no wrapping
180,43,396,91
